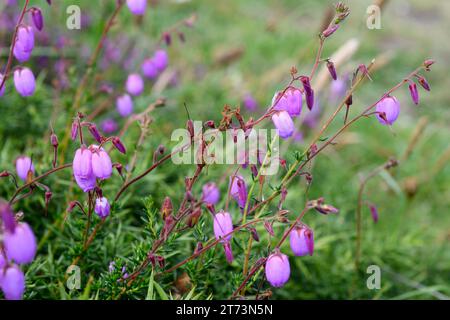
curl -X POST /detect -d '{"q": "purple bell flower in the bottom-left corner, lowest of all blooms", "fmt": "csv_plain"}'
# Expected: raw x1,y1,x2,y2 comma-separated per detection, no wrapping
0,265,25,300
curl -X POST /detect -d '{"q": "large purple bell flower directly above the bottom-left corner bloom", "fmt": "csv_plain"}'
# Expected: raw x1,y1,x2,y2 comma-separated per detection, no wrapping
3,222,37,264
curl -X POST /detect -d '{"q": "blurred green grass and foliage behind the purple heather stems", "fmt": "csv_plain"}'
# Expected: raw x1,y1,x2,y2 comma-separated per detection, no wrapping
0,0,450,299
